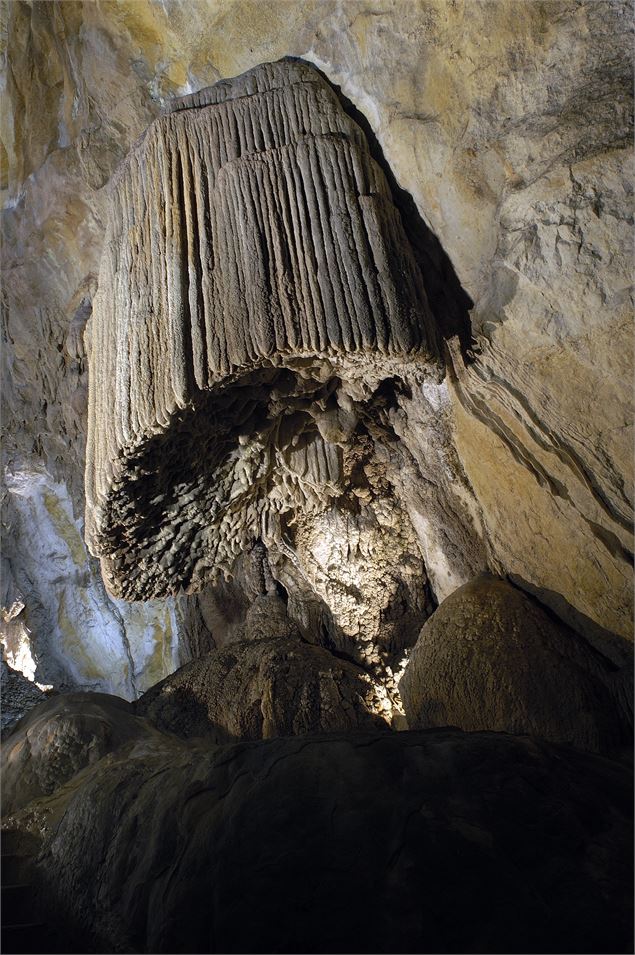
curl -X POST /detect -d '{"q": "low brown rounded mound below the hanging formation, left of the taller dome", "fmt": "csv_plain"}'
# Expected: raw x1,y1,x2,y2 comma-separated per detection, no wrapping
135,636,392,742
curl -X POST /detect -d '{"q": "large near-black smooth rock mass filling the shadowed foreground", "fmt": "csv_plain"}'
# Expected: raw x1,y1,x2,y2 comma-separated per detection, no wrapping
6,730,633,953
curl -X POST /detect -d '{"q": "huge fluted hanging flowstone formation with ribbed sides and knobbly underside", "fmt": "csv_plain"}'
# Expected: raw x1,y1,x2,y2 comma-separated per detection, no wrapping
86,61,438,599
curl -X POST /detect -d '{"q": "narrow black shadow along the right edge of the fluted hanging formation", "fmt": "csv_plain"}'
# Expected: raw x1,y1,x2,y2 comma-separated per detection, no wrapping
283,56,476,364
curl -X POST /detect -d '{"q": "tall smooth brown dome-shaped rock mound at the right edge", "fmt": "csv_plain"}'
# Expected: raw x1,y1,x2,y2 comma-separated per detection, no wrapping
399,575,632,753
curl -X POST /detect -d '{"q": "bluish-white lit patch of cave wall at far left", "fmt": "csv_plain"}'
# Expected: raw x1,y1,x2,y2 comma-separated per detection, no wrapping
0,470,178,699
